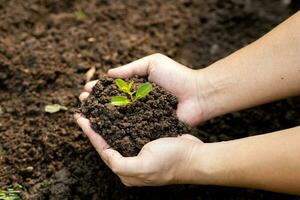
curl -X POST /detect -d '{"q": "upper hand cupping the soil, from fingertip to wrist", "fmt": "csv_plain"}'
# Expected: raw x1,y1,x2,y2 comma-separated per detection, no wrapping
108,54,208,126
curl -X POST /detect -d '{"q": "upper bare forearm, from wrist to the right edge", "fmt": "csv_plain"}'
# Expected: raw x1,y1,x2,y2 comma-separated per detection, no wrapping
199,12,300,118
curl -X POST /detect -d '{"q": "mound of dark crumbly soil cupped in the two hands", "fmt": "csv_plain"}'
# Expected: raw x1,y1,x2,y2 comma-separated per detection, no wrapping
80,77,191,156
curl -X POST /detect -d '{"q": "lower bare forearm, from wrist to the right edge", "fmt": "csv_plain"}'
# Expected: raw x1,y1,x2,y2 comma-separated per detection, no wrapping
191,126,300,195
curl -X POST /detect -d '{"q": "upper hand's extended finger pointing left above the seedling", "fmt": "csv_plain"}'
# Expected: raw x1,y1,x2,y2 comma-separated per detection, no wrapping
107,54,155,78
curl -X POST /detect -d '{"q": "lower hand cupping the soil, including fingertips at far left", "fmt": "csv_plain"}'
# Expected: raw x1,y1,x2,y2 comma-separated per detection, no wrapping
75,81,203,186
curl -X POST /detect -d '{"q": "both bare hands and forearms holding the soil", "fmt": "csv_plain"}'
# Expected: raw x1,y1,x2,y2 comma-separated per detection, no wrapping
75,12,300,195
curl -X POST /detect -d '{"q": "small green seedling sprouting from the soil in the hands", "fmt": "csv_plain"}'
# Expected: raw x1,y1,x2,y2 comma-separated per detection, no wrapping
111,79,153,106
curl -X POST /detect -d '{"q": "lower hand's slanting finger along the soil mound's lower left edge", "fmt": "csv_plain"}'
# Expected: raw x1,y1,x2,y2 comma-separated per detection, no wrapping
74,113,109,154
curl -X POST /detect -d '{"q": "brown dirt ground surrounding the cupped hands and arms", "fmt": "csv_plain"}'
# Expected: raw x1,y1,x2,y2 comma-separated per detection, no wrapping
0,0,300,199
